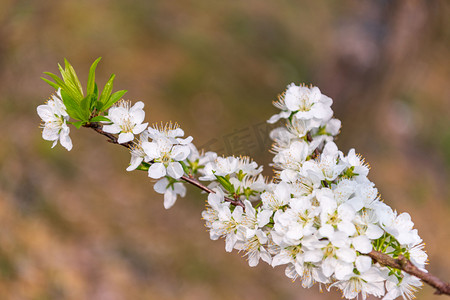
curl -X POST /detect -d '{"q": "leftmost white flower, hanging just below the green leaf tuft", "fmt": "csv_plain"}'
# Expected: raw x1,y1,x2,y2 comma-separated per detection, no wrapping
37,90,72,151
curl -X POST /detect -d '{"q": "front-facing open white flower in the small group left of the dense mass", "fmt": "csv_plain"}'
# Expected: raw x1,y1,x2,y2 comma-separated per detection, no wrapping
142,138,190,179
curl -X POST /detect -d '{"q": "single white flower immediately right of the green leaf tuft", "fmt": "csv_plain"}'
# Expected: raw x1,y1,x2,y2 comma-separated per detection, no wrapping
103,100,148,144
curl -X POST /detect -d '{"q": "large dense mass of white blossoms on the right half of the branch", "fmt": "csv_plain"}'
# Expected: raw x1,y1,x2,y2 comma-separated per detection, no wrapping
200,84,427,299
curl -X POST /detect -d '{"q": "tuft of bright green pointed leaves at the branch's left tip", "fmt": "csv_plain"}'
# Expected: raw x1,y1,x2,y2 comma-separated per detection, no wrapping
41,57,127,128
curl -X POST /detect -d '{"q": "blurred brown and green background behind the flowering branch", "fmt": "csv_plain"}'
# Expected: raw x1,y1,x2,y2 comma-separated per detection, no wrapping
0,0,450,300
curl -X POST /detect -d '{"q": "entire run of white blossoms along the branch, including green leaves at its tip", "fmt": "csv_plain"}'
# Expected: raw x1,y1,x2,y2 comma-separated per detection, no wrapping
37,61,427,300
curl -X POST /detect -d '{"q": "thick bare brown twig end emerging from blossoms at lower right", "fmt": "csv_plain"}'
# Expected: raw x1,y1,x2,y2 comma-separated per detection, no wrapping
367,250,450,295
